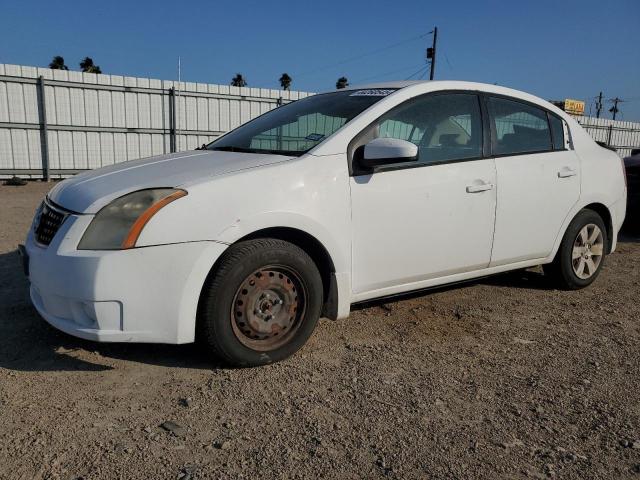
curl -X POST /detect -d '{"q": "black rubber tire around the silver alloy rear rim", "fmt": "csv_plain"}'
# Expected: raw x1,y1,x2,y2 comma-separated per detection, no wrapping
543,209,609,290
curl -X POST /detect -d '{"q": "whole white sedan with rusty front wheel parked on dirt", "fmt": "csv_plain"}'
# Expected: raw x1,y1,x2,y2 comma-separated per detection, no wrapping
22,81,626,366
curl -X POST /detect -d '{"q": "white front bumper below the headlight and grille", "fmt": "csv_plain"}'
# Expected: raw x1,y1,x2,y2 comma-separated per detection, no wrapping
25,215,227,343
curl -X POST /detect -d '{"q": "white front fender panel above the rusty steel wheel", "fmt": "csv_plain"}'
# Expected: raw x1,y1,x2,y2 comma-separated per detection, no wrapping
136,154,351,278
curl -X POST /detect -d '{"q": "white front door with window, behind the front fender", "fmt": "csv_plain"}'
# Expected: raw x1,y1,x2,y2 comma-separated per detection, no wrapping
350,93,496,300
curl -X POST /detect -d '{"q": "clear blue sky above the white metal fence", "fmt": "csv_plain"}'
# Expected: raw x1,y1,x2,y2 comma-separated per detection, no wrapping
0,0,640,120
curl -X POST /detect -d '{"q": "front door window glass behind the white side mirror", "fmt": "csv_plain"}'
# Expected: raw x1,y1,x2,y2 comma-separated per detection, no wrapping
361,93,482,167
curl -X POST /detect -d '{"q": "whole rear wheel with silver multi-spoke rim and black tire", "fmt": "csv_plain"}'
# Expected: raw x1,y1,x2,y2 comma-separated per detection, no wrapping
545,209,608,290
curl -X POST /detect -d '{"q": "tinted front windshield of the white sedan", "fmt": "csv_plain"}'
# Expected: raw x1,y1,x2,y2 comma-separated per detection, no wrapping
206,89,395,155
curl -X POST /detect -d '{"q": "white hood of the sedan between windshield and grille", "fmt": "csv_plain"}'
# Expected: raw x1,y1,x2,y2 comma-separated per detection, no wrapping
48,151,294,213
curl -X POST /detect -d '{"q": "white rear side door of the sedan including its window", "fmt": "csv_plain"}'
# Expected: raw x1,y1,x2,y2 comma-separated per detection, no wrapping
486,96,580,266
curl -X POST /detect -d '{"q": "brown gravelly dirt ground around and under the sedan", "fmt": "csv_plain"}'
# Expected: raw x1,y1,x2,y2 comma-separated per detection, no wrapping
0,183,640,480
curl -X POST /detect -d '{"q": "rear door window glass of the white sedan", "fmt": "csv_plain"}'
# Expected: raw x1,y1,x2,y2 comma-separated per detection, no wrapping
489,97,552,155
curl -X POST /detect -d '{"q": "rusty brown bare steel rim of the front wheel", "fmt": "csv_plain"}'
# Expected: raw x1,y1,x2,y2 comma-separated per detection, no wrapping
231,265,307,351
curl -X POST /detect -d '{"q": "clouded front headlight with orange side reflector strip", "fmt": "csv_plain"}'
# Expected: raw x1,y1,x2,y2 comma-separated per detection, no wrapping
78,188,187,250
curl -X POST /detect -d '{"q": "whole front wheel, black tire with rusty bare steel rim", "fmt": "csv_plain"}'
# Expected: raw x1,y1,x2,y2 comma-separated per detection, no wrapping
197,238,323,367
